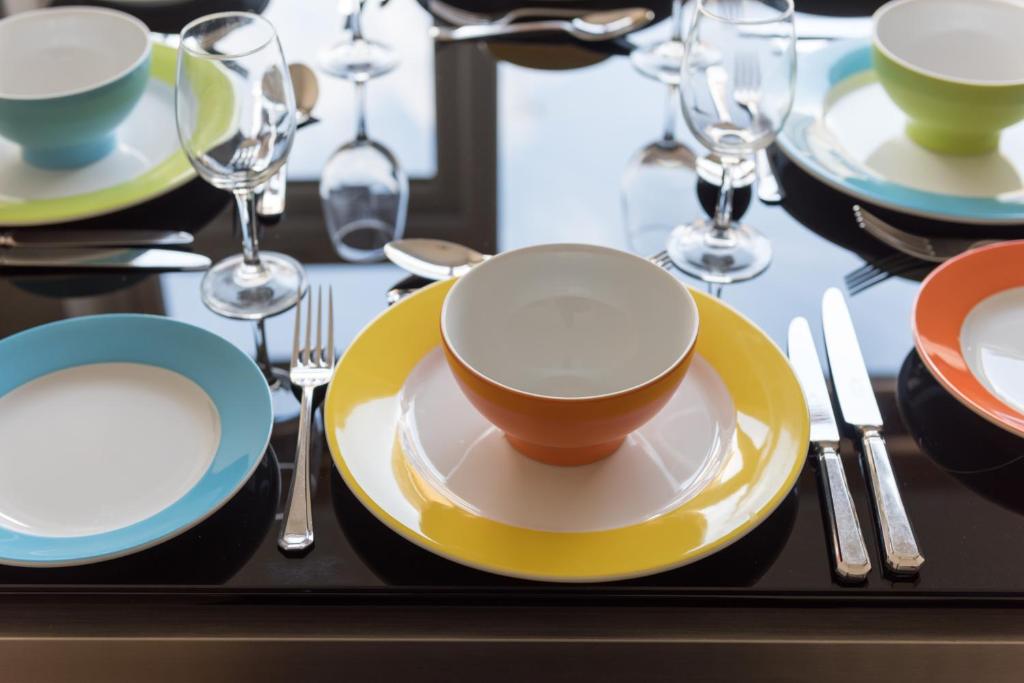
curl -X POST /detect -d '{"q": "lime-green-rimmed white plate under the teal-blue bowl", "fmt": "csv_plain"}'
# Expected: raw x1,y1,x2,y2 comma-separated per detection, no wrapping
0,44,230,227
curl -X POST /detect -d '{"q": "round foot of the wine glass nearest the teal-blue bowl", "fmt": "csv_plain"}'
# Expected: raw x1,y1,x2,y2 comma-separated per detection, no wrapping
200,252,306,321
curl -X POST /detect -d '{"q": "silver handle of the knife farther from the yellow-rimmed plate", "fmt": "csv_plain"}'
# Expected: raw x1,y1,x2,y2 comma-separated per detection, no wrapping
861,429,925,575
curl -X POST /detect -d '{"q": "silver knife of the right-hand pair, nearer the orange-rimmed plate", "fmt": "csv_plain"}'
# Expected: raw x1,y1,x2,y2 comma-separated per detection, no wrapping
821,288,925,574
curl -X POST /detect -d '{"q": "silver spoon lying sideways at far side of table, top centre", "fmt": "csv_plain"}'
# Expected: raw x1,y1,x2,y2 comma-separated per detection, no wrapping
430,7,654,42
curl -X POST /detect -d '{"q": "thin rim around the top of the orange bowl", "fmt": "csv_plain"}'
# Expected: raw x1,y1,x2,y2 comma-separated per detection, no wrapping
440,243,700,403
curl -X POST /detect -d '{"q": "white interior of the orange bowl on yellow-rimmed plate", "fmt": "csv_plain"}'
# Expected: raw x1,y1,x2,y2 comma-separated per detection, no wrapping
441,245,697,398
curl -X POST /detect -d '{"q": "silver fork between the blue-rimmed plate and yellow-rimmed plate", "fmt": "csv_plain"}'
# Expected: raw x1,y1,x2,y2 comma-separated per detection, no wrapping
278,287,334,553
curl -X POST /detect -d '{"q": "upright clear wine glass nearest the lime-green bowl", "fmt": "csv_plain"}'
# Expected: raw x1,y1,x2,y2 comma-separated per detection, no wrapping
668,0,797,284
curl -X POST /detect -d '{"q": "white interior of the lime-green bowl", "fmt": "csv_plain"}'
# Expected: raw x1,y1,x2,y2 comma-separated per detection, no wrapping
874,0,1024,85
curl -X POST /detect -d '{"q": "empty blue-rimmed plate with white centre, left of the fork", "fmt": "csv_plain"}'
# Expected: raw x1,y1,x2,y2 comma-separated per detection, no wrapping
0,314,273,566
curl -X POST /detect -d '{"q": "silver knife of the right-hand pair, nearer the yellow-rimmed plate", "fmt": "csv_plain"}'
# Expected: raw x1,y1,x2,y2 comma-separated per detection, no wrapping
790,317,871,583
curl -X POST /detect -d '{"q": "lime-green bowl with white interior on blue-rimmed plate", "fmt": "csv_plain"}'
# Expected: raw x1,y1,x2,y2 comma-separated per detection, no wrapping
871,0,1024,155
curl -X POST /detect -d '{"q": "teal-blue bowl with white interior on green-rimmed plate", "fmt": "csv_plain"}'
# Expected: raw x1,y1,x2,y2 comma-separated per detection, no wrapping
0,7,151,169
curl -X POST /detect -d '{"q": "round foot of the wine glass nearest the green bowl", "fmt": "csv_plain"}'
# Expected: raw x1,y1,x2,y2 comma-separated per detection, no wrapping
667,219,771,285
